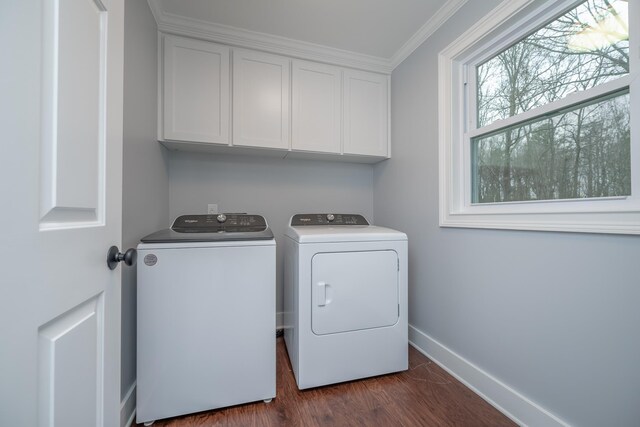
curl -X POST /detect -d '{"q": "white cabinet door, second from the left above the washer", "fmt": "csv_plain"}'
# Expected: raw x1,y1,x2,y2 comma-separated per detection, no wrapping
233,49,290,149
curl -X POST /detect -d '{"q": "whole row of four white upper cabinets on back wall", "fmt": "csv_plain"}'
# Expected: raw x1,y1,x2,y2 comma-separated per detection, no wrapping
158,34,389,163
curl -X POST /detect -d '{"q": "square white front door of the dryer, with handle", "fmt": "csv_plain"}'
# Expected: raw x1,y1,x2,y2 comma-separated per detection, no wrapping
311,250,398,335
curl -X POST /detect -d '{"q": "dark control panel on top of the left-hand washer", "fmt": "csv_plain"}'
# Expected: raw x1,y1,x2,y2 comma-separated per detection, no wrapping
171,214,267,233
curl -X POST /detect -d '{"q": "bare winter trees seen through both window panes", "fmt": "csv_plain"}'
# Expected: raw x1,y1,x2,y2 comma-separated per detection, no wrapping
471,0,631,203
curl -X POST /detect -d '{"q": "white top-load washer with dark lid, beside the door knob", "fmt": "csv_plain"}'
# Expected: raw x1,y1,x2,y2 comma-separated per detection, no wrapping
136,214,276,423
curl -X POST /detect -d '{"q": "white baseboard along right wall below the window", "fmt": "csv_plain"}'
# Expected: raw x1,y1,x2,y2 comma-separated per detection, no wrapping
409,325,569,427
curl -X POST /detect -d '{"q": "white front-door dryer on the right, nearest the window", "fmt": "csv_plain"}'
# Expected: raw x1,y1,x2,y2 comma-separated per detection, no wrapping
284,214,408,389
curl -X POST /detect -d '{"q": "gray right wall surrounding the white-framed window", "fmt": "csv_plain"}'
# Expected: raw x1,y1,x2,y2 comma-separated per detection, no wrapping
374,1,640,426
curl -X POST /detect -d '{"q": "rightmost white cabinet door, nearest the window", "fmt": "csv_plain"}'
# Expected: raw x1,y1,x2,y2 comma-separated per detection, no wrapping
343,70,389,157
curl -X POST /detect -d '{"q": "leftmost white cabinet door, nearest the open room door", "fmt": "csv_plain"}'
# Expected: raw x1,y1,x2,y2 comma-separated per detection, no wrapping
162,35,230,144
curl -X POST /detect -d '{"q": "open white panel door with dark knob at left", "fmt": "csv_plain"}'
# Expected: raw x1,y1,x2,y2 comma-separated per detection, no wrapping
0,0,124,427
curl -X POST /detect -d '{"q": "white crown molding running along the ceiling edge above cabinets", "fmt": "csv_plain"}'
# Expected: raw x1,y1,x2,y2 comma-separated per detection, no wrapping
147,0,467,74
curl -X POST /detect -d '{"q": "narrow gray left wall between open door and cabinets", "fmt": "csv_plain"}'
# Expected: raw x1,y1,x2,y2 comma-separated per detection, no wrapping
121,0,169,406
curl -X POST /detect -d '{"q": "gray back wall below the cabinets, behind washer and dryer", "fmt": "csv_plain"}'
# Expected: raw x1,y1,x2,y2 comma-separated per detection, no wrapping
169,152,373,313
